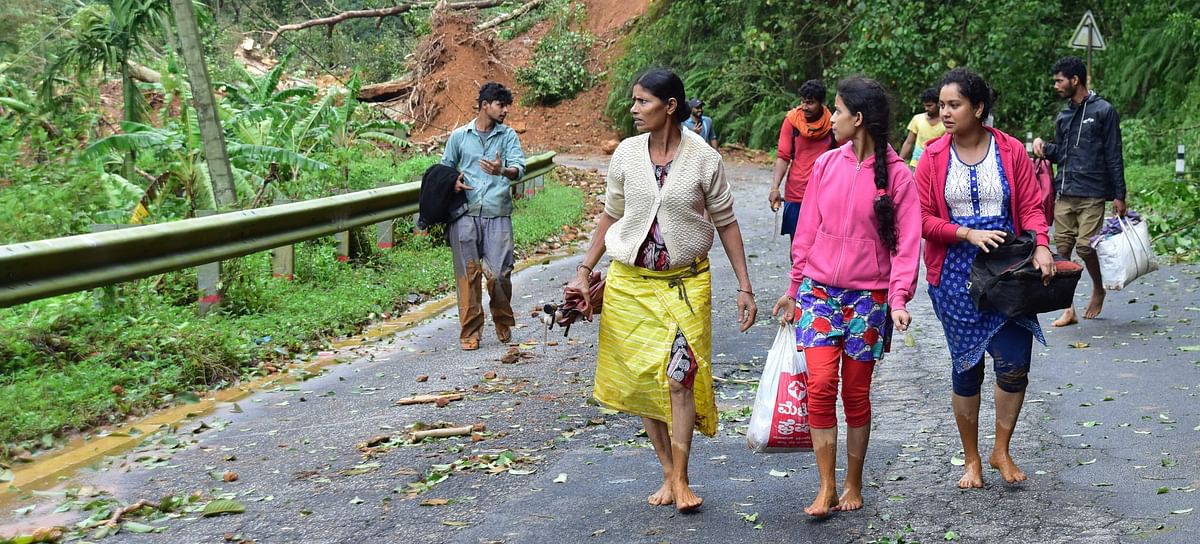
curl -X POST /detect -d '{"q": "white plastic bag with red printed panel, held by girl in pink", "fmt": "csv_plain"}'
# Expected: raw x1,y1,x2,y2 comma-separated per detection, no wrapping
746,323,812,453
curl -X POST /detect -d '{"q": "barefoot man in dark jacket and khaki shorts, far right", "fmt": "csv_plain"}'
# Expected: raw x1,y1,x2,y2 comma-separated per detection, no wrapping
1033,56,1126,327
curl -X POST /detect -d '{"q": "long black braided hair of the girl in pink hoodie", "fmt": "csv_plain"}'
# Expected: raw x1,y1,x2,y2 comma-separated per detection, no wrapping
838,77,896,251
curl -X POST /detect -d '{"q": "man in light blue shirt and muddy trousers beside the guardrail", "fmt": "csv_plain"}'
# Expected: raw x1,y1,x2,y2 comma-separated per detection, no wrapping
442,82,526,351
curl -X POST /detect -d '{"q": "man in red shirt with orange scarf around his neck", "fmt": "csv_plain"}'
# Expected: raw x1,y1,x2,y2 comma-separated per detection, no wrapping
767,79,835,246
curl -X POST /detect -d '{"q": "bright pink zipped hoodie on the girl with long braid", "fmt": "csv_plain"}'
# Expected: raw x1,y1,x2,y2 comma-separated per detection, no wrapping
787,142,920,311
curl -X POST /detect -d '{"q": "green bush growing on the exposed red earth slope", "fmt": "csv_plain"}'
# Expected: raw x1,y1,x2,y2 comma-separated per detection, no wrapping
517,5,595,104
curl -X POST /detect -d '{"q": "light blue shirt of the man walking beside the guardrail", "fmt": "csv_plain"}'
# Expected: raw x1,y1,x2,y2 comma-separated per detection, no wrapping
442,119,524,217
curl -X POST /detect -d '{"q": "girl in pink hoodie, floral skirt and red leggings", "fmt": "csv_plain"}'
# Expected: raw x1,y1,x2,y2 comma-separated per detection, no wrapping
773,78,920,516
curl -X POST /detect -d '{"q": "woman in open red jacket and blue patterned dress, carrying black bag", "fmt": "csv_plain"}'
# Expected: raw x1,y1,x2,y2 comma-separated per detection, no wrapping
917,68,1054,489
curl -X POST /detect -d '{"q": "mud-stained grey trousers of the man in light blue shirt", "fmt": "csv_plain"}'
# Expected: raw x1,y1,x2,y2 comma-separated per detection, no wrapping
446,215,516,341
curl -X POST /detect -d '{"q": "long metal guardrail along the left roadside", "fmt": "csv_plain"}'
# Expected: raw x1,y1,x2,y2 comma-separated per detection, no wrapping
0,151,554,307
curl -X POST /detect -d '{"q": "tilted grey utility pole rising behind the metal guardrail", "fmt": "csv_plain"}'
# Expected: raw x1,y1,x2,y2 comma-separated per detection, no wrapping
170,0,238,209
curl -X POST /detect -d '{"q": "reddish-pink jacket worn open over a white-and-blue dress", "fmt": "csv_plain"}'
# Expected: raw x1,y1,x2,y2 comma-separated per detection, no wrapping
917,127,1050,286
